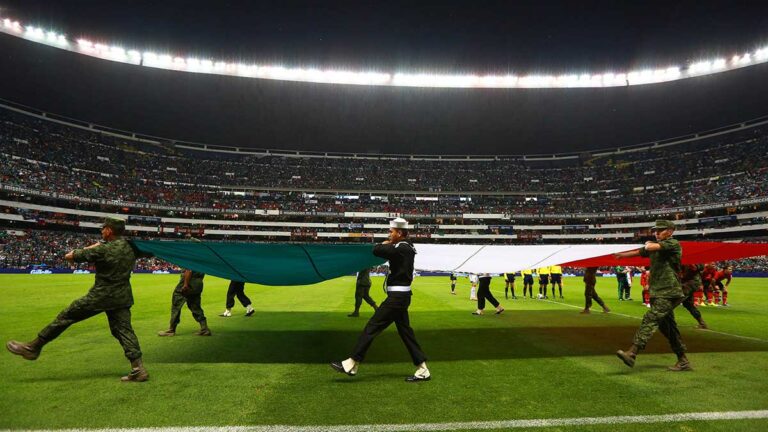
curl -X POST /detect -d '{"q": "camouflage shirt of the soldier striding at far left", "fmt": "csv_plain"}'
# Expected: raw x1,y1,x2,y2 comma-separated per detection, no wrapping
73,238,136,310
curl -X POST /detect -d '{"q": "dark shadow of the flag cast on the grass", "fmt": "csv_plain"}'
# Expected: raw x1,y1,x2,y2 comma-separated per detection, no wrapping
145,311,768,363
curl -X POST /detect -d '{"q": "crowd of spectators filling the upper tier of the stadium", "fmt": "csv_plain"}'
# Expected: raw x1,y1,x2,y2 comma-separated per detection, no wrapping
0,106,768,218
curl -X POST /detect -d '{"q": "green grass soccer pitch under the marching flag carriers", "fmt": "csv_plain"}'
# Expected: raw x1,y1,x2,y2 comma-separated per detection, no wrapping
0,275,768,432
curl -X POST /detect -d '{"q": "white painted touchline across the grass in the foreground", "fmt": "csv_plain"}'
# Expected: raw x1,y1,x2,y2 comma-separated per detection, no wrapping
0,410,768,432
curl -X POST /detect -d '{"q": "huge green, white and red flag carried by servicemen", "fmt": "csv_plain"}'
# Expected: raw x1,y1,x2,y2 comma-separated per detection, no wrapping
133,240,768,285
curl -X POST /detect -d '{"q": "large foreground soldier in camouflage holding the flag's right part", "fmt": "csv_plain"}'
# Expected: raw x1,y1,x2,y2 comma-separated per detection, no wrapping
613,220,693,372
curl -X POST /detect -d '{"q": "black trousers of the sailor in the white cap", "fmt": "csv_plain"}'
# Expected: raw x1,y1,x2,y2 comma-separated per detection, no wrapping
350,292,427,365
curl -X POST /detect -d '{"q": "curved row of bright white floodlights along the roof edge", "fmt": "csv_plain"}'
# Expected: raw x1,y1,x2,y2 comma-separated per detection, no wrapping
1,18,768,88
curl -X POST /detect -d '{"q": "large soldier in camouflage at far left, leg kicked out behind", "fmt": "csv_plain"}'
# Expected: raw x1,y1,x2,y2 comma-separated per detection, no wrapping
6,218,149,382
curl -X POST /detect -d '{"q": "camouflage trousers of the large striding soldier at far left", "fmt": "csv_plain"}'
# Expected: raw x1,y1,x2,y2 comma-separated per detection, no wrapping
38,296,141,361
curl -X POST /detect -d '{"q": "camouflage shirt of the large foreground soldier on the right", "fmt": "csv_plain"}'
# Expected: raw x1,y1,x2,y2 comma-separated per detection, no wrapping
640,238,683,298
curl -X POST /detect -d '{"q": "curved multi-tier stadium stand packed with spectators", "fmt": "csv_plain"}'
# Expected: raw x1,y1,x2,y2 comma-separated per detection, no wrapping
0,101,768,256
